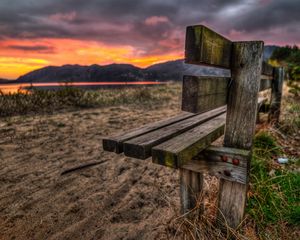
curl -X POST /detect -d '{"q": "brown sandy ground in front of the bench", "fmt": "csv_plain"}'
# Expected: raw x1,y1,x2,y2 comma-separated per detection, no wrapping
0,98,195,240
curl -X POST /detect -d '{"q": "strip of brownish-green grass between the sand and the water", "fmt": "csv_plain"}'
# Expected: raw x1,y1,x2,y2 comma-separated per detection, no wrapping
0,85,179,117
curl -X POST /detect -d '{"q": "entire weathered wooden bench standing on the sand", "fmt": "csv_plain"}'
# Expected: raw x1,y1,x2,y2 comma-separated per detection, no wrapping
103,26,283,228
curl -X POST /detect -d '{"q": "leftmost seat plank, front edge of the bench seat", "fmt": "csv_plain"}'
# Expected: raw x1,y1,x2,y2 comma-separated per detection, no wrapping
102,113,195,154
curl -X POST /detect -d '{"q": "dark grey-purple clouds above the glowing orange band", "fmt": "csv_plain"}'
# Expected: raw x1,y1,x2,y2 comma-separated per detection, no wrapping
0,0,300,54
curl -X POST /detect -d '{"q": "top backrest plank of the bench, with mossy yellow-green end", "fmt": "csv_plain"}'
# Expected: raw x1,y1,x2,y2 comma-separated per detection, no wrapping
185,25,232,68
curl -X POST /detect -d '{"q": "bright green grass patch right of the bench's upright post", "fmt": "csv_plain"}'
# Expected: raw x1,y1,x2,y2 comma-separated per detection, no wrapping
247,132,300,239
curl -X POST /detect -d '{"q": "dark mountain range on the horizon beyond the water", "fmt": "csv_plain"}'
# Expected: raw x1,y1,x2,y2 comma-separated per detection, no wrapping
17,46,276,83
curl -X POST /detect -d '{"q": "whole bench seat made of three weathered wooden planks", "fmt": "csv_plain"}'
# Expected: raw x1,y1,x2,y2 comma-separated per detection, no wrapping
102,97,267,164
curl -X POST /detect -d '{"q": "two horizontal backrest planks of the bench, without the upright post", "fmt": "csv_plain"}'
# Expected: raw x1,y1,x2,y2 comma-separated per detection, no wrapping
182,25,274,113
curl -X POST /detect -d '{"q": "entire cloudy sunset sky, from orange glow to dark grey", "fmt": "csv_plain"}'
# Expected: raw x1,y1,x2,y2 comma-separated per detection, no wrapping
0,0,300,79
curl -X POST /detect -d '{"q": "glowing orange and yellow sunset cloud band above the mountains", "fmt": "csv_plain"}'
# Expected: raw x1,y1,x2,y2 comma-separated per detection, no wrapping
0,39,182,79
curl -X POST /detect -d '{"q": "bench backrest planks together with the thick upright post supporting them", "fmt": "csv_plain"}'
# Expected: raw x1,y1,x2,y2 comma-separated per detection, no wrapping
182,25,283,227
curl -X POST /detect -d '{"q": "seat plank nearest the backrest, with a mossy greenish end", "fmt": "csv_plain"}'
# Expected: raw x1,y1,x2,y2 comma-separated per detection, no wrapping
152,114,226,168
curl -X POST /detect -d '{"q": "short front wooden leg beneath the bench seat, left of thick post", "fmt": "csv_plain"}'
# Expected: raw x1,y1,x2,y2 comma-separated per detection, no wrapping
179,169,203,217
